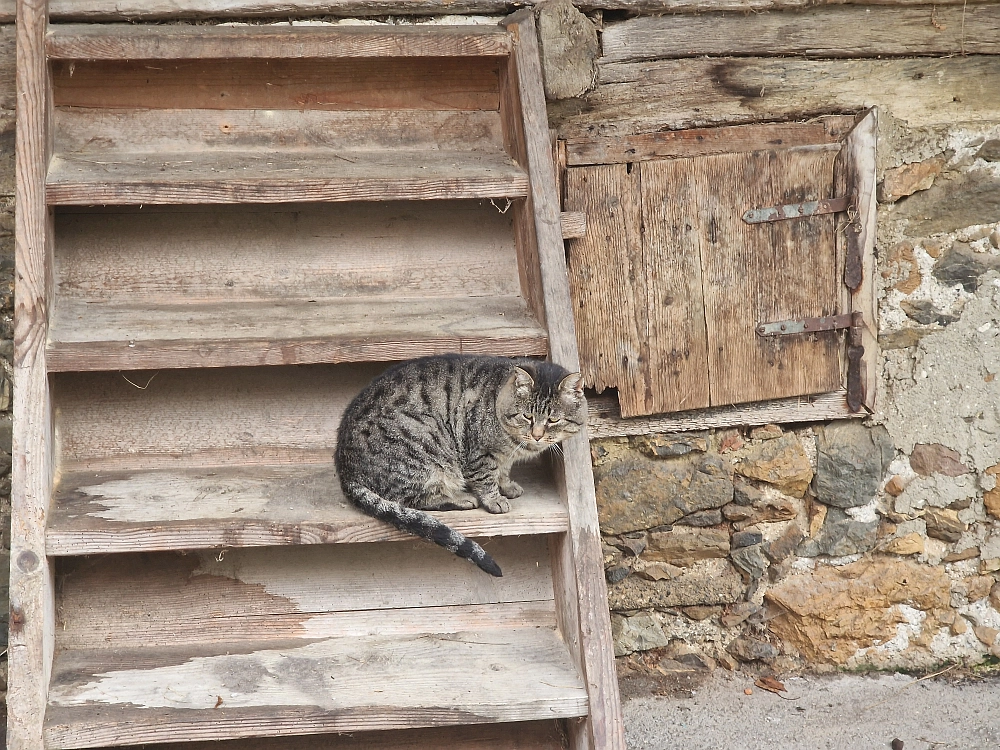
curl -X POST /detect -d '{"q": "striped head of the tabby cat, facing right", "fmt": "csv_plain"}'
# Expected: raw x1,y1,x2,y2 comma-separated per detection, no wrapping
497,362,586,452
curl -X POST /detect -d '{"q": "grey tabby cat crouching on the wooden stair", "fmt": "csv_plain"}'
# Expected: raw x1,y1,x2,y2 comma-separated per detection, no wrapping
336,354,585,576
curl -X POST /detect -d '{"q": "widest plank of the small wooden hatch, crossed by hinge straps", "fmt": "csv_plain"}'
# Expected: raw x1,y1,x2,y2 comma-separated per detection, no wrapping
688,148,842,406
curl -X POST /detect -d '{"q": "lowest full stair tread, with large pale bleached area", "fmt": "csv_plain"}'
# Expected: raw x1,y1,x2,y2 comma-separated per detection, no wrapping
45,627,588,750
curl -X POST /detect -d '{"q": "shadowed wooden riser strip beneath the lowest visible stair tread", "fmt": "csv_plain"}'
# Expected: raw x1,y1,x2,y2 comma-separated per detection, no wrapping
81,721,565,750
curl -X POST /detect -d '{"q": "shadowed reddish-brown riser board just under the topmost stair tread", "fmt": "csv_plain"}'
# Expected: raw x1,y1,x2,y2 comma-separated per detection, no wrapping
52,58,501,110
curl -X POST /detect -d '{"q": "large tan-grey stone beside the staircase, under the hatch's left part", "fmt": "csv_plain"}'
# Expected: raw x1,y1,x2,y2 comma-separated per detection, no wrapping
592,446,733,534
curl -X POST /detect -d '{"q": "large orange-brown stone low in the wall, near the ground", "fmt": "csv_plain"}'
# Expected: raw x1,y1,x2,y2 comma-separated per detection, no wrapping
764,557,951,664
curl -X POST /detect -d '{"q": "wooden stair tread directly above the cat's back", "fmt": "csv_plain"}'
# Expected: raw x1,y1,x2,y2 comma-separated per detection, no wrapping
47,296,547,372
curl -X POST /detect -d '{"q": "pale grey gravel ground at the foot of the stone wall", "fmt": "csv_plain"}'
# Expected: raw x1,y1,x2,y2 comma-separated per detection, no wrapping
624,670,1000,750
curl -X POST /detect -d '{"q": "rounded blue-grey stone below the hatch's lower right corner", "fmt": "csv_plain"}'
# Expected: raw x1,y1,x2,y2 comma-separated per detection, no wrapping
813,420,895,508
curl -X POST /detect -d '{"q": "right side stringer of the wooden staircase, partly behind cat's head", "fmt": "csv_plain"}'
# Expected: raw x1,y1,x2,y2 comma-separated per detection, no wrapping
504,9,625,750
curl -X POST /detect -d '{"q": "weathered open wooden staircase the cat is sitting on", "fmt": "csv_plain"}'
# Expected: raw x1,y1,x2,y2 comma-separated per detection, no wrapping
8,10,624,750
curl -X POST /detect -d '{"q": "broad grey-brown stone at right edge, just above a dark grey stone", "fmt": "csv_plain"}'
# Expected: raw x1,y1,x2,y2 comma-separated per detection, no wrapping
893,169,1000,237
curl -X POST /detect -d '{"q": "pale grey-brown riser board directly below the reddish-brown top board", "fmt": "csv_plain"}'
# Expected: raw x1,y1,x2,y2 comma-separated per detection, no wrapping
53,107,503,160
